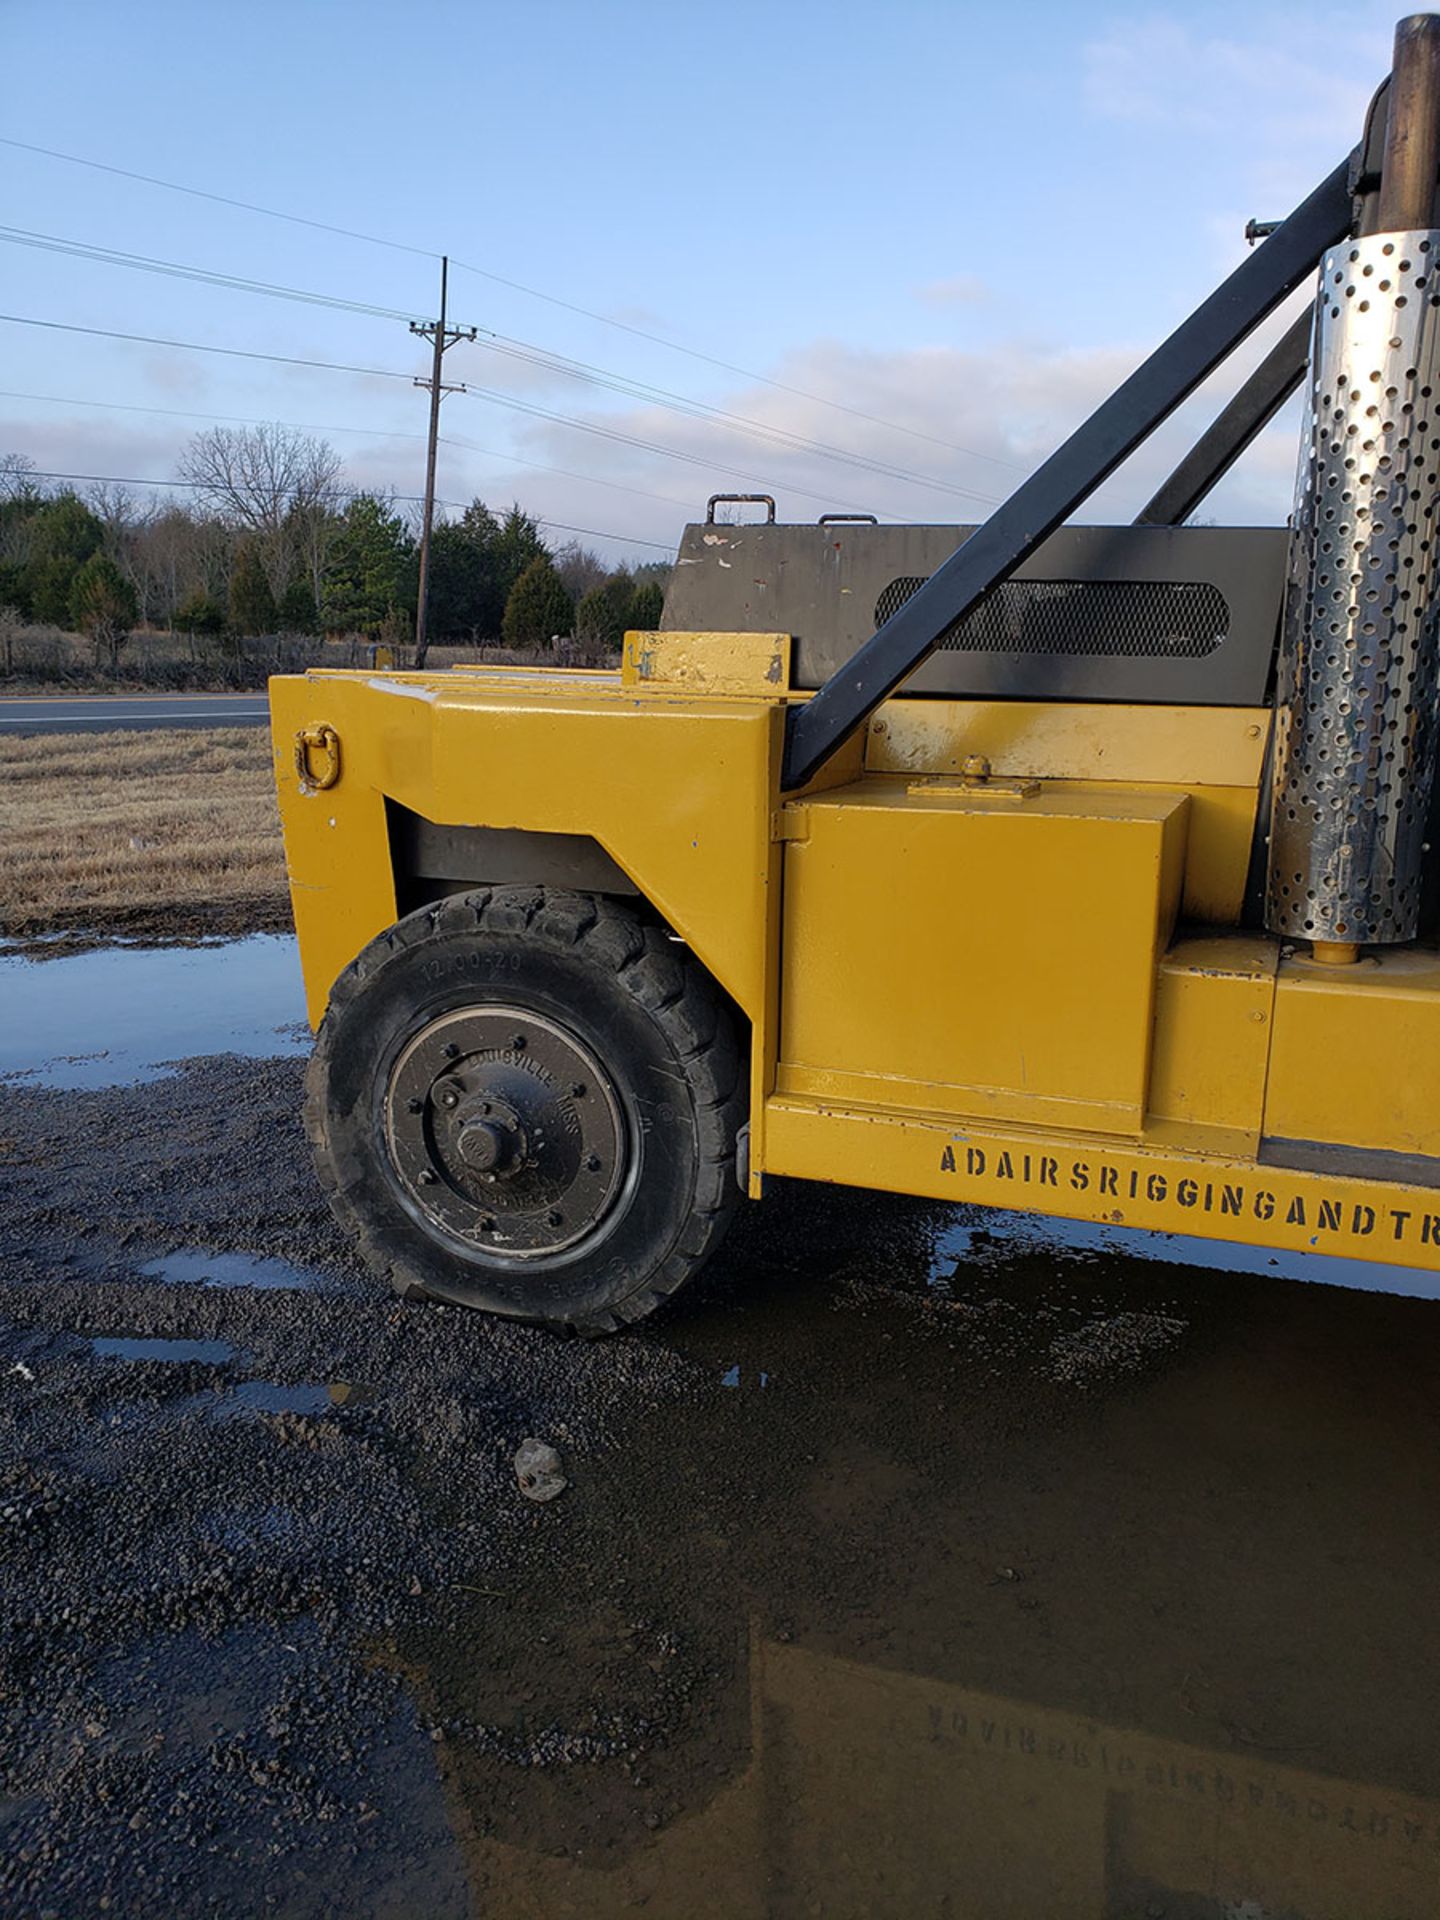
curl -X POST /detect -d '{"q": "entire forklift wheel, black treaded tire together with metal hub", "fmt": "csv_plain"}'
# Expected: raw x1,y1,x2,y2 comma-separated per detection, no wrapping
305,887,743,1332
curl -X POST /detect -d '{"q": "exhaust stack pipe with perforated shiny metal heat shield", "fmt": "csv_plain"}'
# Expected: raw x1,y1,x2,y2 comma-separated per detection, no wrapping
1265,13,1440,964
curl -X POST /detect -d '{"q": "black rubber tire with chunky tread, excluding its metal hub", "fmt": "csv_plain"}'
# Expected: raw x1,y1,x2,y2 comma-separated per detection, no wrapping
305,887,743,1334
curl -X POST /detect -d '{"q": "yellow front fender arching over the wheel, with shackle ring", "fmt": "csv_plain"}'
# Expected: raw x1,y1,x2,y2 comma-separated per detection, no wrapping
271,672,780,1075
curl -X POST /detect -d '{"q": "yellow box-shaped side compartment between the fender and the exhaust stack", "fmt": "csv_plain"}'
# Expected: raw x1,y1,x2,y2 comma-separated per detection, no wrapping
778,778,1188,1133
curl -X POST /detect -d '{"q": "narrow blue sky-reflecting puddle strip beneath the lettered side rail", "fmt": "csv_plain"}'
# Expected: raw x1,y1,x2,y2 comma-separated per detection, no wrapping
929,1212,1440,1300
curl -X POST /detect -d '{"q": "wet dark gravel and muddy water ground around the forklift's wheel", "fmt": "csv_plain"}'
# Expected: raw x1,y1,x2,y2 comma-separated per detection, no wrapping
0,936,1440,1920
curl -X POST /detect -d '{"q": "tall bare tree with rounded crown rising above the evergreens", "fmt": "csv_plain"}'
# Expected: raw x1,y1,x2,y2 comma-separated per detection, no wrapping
180,424,340,599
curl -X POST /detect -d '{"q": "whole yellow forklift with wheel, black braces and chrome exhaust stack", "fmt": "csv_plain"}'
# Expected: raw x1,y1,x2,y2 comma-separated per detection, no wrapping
271,15,1440,1332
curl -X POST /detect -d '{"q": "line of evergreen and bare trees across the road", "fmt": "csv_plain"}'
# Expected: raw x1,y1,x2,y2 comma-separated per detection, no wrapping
0,426,670,664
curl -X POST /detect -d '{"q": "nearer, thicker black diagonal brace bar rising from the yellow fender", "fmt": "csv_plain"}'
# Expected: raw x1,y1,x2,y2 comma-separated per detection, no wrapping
783,161,1352,789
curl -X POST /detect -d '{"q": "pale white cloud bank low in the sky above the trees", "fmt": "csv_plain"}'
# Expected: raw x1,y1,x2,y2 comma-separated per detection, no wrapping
0,295,1294,559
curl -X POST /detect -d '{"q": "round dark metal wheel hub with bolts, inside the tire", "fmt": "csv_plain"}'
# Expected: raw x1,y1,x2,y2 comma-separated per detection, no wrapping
384,1006,628,1260
